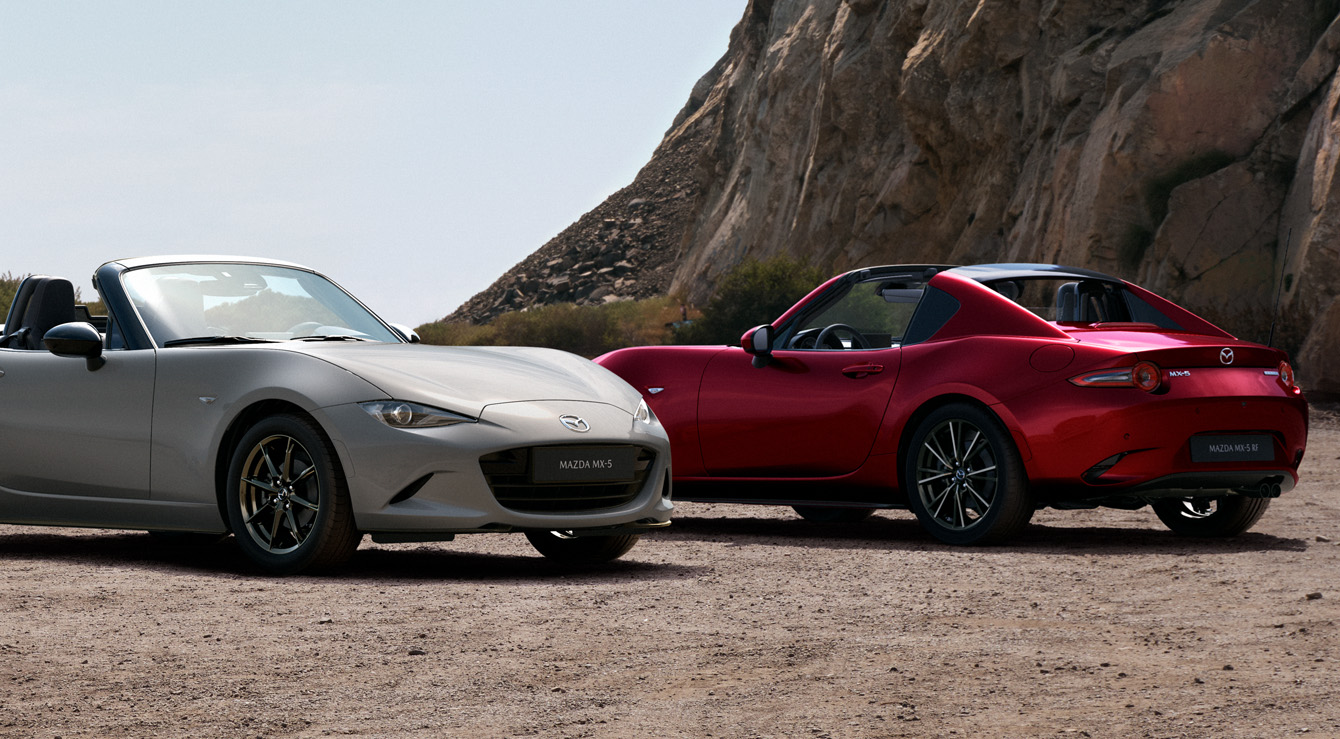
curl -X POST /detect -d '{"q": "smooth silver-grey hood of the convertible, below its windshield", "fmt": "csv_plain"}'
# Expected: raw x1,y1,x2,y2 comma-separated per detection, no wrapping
284,342,642,417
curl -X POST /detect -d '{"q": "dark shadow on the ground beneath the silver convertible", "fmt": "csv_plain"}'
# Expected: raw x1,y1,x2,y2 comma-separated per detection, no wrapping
0,531,706,585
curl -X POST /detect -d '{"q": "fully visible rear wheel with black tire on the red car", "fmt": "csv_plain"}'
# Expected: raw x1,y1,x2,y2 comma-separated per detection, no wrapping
903,404,1033,545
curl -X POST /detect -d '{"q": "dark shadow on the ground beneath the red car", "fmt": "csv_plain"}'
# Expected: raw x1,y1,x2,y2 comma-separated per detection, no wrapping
657,512,1308,555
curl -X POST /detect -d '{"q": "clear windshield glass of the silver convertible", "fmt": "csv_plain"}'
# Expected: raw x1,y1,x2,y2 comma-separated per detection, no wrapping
122,263,399,346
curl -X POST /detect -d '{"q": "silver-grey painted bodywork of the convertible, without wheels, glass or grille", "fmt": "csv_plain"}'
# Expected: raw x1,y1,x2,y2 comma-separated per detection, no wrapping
0,258,671,541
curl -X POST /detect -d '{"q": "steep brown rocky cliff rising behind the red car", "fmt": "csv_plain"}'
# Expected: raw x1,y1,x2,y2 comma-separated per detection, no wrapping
454,0,1340,390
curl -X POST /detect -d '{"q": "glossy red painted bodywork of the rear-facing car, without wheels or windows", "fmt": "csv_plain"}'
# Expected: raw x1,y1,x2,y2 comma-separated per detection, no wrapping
596,266,1308,507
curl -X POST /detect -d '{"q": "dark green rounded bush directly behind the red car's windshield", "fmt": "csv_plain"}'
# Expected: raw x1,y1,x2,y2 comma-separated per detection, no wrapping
674,256,825,343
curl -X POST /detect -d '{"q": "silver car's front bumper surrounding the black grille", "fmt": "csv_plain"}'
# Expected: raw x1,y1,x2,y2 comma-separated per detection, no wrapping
316,401,674,541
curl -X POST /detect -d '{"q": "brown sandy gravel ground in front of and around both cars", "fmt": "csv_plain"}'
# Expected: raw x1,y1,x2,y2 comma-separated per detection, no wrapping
0,413,1340,738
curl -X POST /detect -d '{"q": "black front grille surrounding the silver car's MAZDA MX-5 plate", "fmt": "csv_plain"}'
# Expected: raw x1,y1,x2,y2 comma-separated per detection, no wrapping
480,447,657,514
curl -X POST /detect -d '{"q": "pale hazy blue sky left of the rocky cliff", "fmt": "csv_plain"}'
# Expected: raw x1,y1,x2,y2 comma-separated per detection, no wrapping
0,0,746,326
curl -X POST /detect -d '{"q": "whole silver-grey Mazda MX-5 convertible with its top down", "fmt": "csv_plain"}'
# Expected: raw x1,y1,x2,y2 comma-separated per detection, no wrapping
0,256,673,574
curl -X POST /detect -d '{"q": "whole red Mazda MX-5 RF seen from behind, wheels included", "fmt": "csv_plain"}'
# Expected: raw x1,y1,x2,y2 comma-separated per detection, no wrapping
596,264,1308,545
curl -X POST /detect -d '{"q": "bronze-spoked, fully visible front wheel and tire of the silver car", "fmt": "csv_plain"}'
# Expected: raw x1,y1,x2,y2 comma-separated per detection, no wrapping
225,414,362,575
